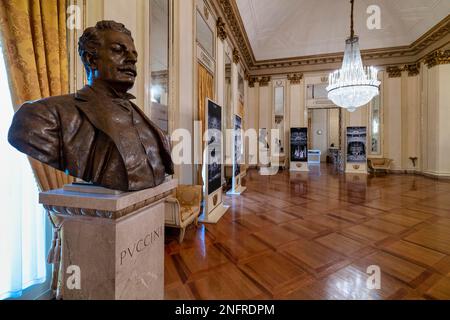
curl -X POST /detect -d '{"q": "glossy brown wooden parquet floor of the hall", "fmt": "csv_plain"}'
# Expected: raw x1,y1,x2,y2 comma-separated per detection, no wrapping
165,166,450,300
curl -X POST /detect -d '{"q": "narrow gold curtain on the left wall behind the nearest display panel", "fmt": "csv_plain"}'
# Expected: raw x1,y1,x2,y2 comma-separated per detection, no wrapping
197,63,214,184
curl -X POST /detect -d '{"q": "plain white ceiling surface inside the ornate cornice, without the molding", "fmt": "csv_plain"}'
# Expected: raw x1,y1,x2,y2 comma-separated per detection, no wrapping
236,0,450,61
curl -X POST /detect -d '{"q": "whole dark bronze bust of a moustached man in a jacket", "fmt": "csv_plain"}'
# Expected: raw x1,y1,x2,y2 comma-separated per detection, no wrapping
8,21,173,191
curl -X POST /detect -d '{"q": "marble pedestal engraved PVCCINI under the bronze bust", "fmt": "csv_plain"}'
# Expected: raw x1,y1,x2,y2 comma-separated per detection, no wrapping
39,180,177,300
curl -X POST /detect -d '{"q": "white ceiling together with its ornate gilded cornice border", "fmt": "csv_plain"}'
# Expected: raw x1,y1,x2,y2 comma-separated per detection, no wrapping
214,0,450,75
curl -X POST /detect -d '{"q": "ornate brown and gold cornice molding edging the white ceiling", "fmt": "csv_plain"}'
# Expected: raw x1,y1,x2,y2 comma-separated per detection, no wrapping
213,0,450,73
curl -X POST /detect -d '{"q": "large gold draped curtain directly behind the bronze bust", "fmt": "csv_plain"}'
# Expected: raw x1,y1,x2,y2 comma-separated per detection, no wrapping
0,0,73,191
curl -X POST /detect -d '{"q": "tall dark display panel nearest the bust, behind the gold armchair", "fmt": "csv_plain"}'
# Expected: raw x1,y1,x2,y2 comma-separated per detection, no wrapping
207,100,222,195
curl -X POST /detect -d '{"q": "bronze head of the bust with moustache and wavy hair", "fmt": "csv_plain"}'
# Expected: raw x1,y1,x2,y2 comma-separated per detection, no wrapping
78,21,137,92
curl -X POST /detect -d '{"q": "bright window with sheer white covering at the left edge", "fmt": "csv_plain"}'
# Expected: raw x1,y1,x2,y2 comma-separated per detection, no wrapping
0,45,48,299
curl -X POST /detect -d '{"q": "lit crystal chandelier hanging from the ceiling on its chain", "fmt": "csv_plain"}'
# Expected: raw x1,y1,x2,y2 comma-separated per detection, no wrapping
327,0,381,112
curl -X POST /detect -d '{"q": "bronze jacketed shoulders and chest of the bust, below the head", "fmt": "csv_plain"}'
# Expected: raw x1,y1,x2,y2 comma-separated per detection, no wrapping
8,86,173,191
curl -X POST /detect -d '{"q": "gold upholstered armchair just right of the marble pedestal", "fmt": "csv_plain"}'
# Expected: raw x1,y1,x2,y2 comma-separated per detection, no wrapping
165,185,202,243
